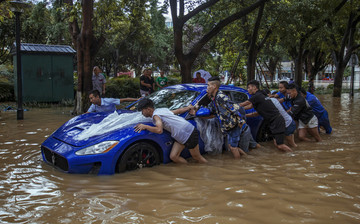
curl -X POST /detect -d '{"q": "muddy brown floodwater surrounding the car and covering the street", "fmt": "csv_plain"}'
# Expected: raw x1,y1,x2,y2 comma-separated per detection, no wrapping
0,94,360,224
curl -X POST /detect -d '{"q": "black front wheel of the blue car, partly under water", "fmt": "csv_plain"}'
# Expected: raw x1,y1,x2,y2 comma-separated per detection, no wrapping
117,142,160,173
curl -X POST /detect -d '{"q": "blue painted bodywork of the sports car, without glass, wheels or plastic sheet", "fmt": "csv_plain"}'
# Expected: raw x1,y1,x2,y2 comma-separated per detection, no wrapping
41,84,262,174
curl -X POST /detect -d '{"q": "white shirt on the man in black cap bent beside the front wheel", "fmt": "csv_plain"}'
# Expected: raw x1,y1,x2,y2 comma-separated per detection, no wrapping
152,108,195,144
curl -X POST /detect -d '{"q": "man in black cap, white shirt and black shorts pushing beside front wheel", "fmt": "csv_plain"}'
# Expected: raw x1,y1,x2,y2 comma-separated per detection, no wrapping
134,98,207,163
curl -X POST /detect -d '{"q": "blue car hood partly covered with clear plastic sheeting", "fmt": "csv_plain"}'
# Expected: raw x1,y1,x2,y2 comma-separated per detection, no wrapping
52,110,152,147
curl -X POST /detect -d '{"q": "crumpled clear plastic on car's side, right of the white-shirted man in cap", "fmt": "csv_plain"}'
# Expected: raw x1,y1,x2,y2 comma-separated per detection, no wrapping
195,117,224,154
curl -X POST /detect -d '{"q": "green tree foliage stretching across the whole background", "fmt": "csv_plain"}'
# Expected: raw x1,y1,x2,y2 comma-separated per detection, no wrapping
0,0,360,102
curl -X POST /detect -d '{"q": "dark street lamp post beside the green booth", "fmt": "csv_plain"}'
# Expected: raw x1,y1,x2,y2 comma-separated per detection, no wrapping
10,0,27,120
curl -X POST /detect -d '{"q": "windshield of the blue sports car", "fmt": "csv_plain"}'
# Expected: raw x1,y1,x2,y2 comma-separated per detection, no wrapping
130,89,200,110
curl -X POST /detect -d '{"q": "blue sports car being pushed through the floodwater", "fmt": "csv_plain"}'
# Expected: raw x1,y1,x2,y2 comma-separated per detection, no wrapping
41,84,266,174
